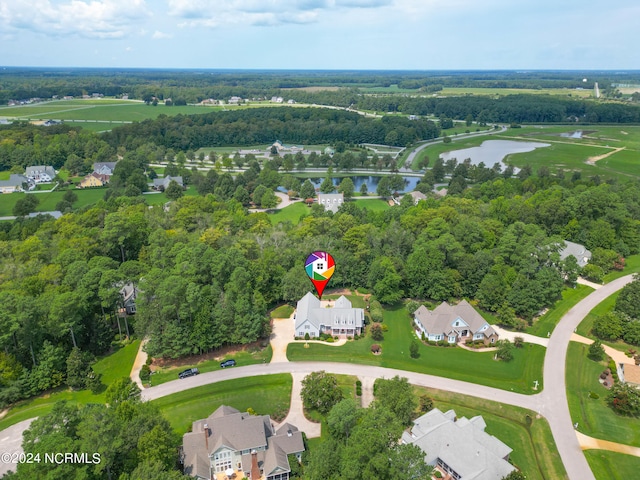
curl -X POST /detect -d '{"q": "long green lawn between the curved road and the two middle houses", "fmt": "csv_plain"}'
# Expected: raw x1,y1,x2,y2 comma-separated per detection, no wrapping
287,306,545,394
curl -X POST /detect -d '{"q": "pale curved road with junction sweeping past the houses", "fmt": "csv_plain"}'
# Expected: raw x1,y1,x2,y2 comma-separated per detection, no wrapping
0,275,633,480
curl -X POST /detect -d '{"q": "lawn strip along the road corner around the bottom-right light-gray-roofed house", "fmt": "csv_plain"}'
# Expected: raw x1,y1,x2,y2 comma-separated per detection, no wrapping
415,387,567,480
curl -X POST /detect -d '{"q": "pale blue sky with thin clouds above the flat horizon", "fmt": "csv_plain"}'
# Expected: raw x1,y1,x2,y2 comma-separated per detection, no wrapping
0,0,640,71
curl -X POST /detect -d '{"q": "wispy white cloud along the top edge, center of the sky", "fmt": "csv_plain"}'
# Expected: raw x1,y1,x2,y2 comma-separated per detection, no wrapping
168,0,394,27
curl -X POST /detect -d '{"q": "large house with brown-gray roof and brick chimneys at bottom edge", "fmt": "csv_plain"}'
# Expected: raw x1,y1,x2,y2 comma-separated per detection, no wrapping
181,405,305,480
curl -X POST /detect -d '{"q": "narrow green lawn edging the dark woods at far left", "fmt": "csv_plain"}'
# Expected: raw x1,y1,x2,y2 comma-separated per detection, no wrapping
0,340,140,430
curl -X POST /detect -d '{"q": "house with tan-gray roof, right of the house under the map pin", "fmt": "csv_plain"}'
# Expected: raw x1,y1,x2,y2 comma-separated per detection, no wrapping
413,300,498,345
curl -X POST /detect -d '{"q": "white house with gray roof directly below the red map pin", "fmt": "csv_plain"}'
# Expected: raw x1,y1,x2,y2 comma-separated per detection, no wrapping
293,292,364,338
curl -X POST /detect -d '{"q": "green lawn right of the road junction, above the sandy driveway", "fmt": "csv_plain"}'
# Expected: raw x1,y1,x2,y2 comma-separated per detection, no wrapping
566,342,640,447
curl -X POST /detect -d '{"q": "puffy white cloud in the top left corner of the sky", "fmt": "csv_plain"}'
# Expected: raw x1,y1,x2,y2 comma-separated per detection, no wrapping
0,0,151,38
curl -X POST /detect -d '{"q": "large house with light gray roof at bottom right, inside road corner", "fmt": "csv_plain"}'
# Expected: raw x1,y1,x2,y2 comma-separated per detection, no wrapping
401,408,516,480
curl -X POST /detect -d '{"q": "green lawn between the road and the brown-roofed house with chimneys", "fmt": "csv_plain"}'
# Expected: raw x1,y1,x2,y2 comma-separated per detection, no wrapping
152,373,293,435
